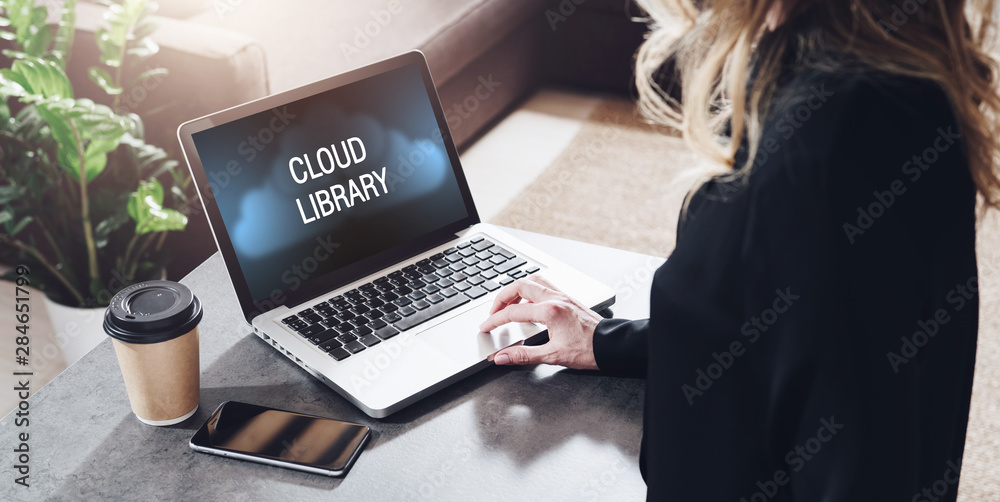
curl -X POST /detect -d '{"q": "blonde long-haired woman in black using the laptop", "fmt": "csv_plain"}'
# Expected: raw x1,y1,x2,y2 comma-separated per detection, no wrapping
482,0,1000,501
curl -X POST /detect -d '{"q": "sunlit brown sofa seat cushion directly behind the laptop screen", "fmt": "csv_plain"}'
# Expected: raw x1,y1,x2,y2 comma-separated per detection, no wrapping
191,0,543,91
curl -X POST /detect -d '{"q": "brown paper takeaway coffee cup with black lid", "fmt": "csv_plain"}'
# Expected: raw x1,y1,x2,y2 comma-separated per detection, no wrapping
104,281,202,426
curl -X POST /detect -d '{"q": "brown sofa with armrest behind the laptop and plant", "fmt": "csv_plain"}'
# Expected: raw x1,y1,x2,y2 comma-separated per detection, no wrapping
9,0,645,277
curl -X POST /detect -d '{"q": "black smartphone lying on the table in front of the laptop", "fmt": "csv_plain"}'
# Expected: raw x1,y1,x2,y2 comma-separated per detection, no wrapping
190,401,371,476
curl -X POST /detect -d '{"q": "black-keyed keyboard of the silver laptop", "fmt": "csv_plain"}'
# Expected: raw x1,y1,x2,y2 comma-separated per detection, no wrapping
281,236,539,361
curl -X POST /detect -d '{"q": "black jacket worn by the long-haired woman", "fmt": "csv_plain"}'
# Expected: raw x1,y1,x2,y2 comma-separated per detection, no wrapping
594,67,978,502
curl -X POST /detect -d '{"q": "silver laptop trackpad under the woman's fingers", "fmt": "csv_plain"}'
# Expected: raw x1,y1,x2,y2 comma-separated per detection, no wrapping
417,303,545,366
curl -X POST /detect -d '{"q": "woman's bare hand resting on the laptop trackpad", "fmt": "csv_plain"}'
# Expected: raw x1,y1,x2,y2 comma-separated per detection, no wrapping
479,276,601,370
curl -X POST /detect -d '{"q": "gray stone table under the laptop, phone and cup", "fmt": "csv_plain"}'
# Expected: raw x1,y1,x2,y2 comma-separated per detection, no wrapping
0,230,663,501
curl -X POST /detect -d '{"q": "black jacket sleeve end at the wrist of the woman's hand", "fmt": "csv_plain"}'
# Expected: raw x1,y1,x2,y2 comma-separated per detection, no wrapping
594,319,649,378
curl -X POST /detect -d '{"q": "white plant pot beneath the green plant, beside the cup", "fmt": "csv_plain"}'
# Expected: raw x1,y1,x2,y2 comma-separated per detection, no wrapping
45,297,108,366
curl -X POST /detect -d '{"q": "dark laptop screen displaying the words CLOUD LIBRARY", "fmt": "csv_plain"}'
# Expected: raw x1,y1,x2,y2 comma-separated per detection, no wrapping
191,57,474,311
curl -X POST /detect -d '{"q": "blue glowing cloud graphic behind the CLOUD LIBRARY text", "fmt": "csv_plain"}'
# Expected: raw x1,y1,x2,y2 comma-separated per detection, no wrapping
231,106,451,258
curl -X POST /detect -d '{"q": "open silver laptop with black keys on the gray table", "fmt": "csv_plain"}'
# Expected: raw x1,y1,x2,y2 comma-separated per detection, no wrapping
177,51,615,418
